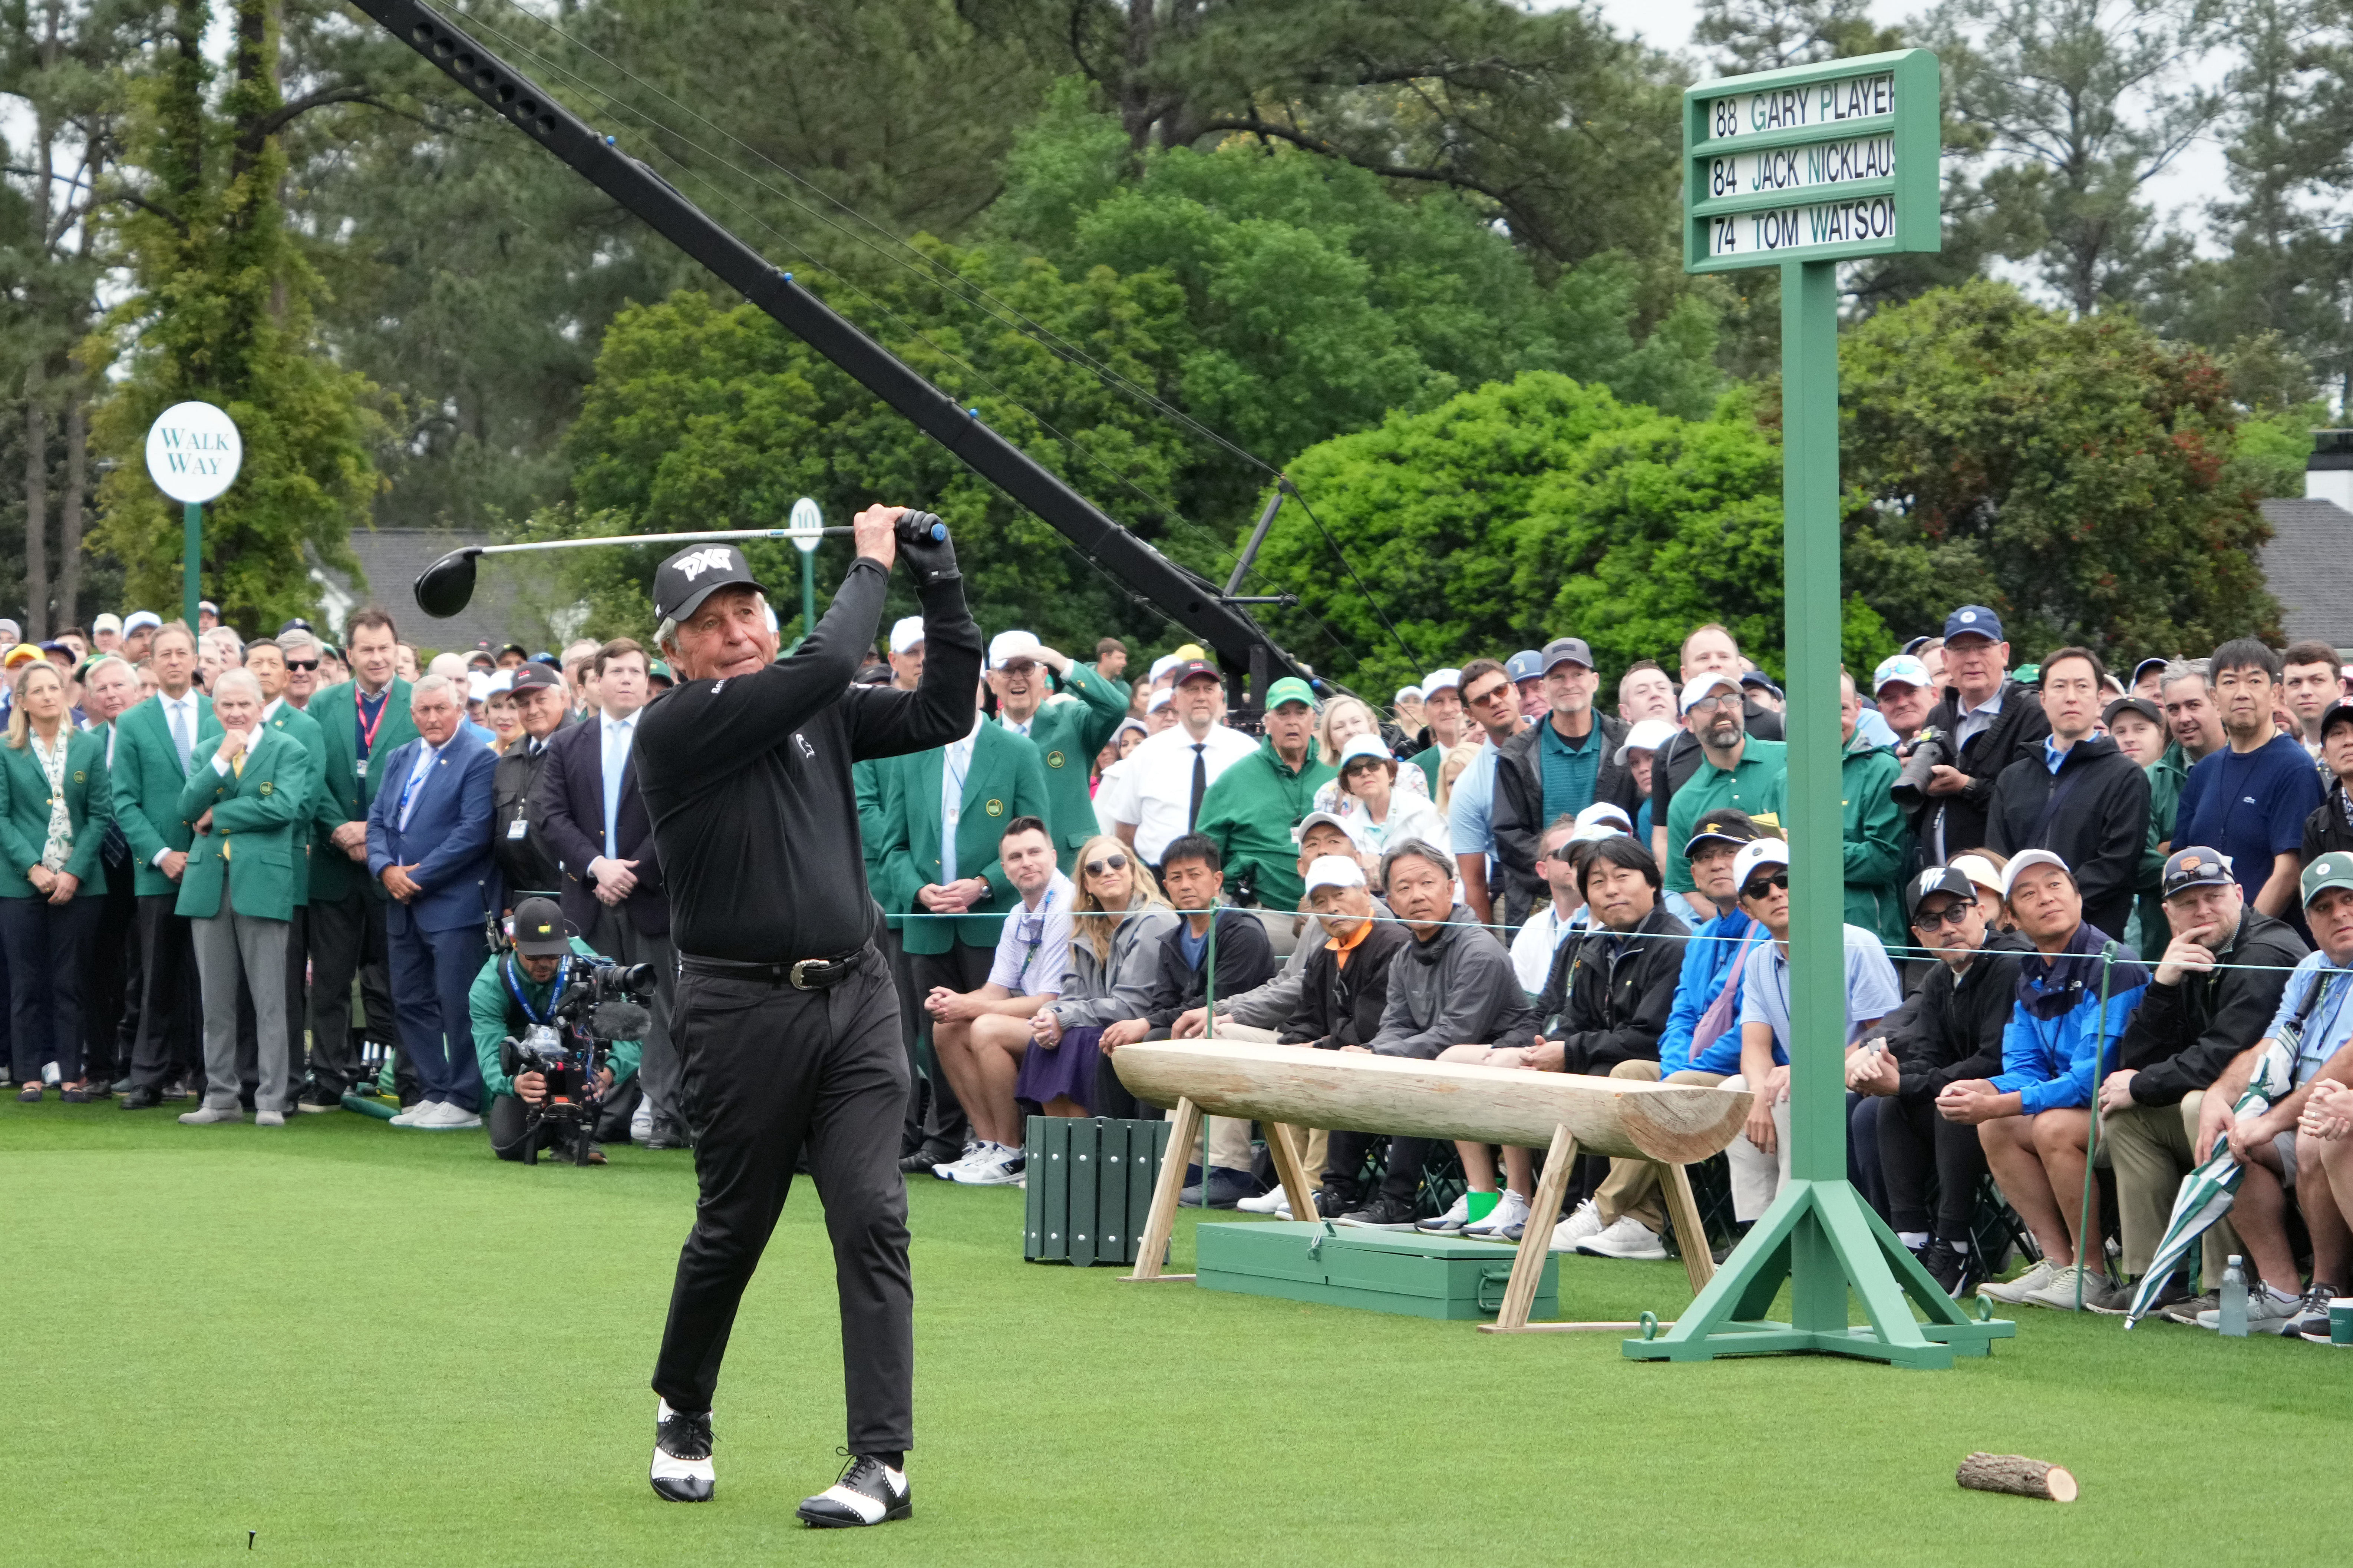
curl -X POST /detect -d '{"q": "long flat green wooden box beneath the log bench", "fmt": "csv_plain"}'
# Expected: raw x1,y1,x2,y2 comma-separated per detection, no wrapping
1193,1220,1560,1321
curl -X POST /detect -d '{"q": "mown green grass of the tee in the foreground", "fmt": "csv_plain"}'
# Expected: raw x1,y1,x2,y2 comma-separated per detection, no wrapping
0,1100,2353,1568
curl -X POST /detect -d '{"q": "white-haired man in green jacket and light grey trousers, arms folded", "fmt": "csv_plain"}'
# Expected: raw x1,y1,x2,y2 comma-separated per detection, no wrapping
176,670,313,1126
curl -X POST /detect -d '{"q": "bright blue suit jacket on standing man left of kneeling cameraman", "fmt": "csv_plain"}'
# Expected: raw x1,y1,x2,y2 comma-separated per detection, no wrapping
367,734,501,931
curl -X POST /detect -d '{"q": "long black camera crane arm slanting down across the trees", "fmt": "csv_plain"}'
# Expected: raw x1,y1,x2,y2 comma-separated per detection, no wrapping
351,0,1304,705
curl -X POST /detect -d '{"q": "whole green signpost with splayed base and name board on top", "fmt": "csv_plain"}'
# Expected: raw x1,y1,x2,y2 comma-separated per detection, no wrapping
1626,49,2014,1368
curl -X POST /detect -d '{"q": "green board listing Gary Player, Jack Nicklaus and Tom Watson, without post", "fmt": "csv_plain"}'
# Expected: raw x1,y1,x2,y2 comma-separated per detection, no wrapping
1682,49,1944,273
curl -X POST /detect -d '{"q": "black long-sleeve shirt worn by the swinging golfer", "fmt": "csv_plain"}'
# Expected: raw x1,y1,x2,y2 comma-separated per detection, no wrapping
635,555,981,964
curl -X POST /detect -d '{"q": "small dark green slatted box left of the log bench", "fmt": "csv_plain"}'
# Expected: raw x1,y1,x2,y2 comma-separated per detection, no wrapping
1021,1117,1174,1267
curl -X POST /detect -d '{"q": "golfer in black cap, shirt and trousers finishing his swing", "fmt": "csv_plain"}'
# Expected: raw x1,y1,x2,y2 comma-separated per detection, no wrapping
635,505,981,1526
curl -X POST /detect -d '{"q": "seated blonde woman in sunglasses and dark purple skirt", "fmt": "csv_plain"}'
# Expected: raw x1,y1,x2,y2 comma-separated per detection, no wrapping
1014,834,1176,1117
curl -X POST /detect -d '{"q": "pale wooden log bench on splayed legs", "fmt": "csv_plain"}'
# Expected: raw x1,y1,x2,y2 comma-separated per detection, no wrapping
1111,1039,1750,1333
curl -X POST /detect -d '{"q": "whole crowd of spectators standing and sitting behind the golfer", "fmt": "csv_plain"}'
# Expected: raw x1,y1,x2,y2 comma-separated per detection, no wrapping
0,604,2353,1342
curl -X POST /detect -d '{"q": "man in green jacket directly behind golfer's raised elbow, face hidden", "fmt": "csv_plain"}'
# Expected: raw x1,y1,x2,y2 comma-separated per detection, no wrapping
861,691,1052,1171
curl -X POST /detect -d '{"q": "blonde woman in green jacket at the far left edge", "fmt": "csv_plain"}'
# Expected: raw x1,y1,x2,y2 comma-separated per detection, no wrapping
0,661,106,1100
